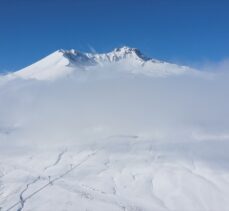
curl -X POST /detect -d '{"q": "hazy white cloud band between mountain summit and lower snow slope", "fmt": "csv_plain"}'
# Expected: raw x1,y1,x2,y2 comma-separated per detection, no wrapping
0,69,229,169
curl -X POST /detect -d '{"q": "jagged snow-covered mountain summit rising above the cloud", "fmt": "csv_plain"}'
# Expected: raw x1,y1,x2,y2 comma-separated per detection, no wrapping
10,46,196,80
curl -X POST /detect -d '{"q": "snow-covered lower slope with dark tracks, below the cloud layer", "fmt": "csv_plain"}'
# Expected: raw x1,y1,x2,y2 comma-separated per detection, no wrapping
0,136,229,211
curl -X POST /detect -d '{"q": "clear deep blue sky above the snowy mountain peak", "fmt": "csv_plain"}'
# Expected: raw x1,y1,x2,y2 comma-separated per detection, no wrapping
0,0,229,71
